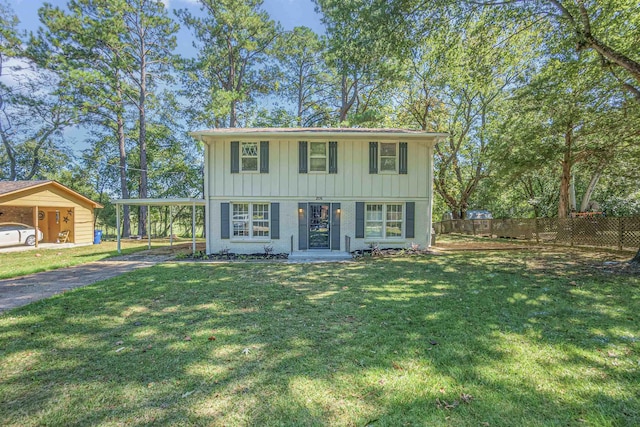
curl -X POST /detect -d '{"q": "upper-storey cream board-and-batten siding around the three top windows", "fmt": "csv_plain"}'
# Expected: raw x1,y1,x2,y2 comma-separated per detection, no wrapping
207,138,433,200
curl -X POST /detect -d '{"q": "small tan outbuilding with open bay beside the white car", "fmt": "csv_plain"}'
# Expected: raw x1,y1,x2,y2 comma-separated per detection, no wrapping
0,181,102,244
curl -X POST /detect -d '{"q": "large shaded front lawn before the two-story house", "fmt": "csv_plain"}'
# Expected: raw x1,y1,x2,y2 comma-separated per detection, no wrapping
0,251,640,426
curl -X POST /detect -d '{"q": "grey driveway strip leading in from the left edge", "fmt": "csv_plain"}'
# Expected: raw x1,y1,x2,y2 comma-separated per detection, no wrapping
0,252,173,312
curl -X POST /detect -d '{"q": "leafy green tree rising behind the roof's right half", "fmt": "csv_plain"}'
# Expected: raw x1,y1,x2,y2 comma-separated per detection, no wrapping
314,0,407,126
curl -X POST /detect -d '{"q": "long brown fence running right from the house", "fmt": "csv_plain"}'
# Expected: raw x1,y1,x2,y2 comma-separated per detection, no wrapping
434,217,640,250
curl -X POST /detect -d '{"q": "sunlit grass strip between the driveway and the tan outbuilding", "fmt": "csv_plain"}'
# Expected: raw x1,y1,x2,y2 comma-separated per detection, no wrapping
0,240,192,279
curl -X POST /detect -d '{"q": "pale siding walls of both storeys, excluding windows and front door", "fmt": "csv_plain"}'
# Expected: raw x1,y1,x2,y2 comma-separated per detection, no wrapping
194,129,443,253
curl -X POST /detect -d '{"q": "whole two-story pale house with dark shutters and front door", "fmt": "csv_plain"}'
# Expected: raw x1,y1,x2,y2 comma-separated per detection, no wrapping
192,128,446,253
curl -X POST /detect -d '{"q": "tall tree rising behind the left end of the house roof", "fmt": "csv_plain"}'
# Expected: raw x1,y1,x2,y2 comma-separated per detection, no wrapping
176,0,281,127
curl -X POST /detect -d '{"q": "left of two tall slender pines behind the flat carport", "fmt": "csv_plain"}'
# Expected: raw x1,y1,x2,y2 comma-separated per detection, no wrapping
29,0,135,237
